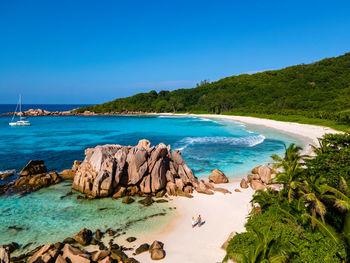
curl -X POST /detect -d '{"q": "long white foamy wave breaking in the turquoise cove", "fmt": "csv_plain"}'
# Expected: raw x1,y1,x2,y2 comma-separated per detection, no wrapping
177,135,265,151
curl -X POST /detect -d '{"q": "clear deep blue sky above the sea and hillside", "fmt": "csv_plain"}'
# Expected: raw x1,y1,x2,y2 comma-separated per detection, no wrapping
0,0,350,103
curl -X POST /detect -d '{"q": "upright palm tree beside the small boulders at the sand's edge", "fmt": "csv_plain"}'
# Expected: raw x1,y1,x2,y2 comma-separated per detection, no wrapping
271,143,305,202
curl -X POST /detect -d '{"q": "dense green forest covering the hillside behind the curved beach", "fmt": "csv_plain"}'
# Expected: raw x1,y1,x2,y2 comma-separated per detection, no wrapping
78,53,350,123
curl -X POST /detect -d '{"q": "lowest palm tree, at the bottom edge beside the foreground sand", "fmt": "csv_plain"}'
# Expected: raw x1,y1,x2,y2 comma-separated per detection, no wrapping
223,229,289,263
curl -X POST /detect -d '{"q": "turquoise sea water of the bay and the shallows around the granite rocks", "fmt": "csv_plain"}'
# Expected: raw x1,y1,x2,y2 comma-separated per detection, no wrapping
0,116,302,253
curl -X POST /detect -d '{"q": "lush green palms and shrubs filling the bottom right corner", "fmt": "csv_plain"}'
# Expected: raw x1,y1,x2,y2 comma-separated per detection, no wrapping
224,134,350,263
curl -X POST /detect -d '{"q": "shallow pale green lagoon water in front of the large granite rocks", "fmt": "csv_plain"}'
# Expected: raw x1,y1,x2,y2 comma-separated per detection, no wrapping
0,181,175,253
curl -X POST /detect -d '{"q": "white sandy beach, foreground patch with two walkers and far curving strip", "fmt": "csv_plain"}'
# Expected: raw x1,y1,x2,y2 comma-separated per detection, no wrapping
124,114,337,263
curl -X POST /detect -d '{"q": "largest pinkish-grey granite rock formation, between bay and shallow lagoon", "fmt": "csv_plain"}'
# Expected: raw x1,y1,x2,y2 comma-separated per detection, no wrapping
72,139,208,198
